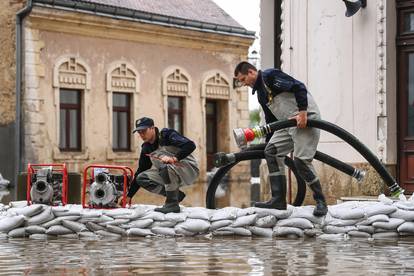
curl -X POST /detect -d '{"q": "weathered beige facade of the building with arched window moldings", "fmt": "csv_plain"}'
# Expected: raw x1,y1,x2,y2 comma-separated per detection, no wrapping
18,7,252,206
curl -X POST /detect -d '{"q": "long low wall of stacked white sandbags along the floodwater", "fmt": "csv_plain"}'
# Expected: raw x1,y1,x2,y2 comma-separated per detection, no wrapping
0,195,414,240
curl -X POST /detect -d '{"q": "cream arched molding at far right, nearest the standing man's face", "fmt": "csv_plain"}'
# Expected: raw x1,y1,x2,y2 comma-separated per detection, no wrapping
201,70,231,100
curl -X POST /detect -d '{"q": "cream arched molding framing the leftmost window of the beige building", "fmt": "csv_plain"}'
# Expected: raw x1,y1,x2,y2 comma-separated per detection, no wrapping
53,55,91,160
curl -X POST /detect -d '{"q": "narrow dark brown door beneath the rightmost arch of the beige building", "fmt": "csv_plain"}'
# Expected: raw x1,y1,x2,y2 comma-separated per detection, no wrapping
206,100,218,171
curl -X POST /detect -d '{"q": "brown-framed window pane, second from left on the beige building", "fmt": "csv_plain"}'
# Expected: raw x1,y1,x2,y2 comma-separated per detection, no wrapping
112,93,131,151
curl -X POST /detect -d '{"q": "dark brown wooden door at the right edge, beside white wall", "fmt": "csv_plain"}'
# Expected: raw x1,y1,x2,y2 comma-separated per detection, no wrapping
397,1,414,193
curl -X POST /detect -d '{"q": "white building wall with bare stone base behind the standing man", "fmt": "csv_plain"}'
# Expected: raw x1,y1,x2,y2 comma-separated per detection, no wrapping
261,0,397,203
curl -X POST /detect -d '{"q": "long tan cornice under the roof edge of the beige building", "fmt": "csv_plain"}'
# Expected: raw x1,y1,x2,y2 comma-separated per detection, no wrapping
28,7,253,55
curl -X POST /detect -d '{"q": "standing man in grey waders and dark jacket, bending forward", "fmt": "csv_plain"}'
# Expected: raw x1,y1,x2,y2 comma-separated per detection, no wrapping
234,61,328,216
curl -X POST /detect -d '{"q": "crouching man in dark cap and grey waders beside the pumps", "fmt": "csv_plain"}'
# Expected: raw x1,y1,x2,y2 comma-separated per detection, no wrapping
120,117,199,213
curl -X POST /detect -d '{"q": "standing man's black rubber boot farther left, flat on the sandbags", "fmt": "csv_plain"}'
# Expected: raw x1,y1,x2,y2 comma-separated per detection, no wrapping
254,175,286,210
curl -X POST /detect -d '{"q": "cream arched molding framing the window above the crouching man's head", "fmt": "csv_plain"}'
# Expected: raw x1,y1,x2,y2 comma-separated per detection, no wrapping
162,65,191,135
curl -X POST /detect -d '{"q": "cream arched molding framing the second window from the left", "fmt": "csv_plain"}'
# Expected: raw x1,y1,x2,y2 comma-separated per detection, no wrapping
106,61,140,160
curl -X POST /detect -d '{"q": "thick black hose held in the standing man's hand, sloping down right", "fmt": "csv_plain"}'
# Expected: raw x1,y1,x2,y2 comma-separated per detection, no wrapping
254,119,404,196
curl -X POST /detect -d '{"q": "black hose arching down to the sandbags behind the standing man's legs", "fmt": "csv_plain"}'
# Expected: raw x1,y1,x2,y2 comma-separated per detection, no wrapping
206,153,306,209
